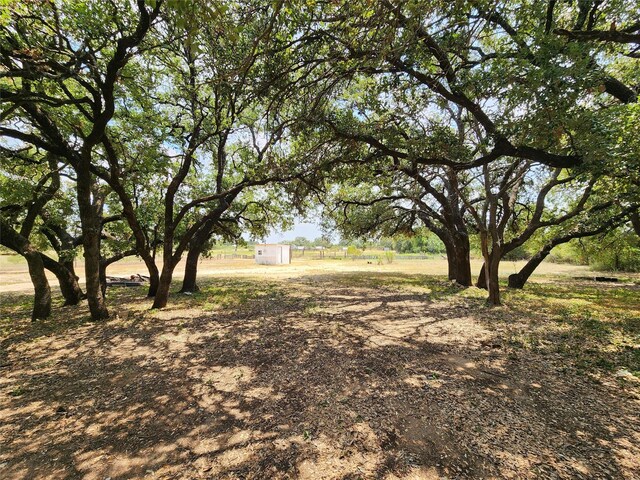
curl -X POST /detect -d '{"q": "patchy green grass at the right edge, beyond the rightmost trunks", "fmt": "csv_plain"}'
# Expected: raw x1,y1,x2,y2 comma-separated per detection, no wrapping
501,282,640,378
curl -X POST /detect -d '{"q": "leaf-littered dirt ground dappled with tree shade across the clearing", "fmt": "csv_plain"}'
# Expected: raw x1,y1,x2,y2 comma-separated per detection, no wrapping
0,262,640,480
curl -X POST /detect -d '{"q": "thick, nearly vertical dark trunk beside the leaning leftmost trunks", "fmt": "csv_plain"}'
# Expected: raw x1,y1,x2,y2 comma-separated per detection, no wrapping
76,169,109,321
